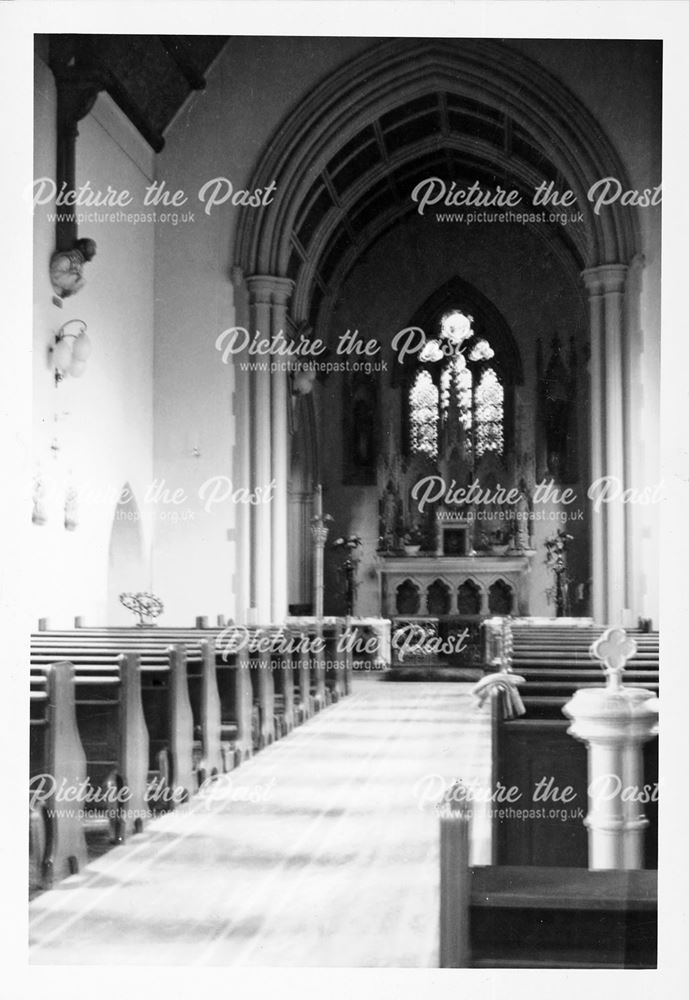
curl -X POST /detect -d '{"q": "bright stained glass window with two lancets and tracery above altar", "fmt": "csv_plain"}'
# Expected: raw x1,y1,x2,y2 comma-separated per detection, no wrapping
408,311,505,461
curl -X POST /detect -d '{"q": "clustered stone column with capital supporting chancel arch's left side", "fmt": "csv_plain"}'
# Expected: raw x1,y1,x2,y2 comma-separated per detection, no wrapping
246,275,293,624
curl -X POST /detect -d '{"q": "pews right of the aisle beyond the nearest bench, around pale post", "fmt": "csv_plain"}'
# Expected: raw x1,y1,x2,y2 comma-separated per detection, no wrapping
483,618,660,869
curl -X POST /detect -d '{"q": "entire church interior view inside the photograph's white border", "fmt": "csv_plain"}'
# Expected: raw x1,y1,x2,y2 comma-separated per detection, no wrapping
28,34,662,969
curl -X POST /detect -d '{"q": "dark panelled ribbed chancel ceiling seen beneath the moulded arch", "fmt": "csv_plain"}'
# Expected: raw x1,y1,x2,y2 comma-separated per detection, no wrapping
287,91,585,326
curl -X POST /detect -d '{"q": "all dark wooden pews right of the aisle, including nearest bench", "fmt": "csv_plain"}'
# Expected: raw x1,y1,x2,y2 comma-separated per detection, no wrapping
432,617,659,969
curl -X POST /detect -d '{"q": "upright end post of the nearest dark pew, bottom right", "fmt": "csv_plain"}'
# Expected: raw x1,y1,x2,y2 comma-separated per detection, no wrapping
438,781,471,969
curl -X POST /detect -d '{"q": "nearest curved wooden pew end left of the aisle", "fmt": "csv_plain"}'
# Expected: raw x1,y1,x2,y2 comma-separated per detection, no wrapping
29,661,87,889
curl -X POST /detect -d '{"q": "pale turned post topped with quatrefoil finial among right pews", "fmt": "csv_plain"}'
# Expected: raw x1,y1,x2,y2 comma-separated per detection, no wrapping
563,628,658,869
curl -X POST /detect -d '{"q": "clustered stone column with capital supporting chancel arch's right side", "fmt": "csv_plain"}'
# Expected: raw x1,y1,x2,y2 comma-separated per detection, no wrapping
582,264,629,624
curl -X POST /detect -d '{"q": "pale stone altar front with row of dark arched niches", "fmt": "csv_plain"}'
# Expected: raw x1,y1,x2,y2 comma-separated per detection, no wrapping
379,553,531,618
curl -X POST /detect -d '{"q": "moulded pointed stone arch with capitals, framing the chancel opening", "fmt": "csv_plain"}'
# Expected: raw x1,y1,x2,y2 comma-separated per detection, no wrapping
235,39,638,296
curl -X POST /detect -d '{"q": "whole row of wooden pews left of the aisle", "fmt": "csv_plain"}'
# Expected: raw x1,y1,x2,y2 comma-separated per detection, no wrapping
29,619,353,890
